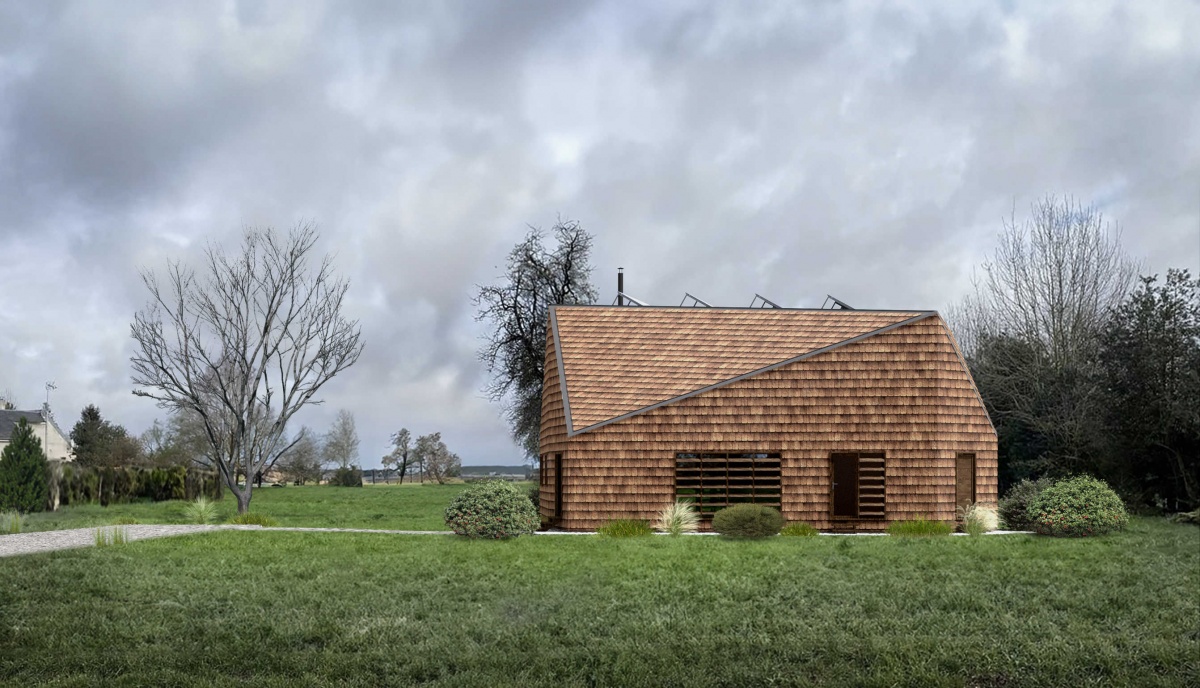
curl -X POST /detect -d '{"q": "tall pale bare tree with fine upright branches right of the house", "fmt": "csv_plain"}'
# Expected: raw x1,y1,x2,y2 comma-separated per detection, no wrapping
950,198,1138,472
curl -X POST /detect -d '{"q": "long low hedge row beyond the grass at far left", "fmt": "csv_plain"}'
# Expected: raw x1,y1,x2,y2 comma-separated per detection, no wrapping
50,463,222,507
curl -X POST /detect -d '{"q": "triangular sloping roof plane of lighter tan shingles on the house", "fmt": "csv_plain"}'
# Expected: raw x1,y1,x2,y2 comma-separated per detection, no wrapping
551,306,931,432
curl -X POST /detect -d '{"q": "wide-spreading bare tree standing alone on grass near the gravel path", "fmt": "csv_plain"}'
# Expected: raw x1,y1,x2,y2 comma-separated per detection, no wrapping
131,225,362,513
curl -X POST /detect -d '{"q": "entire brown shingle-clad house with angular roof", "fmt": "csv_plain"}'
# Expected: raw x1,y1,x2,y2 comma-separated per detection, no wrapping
540,306,997,531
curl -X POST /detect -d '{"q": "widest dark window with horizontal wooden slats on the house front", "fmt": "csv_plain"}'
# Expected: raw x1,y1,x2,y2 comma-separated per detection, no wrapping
676,453,781,520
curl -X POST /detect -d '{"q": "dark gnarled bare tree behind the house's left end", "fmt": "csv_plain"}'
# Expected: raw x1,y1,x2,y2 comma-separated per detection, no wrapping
474,220,596,462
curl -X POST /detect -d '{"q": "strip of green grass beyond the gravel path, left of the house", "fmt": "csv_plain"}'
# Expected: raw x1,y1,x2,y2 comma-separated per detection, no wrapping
18,483,477,531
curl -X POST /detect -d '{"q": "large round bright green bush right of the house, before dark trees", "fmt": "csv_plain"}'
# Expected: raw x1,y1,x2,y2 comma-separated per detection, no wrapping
1028,475,1129,538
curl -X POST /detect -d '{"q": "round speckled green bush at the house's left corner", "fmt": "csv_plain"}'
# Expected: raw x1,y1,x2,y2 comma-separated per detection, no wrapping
445,480,541,539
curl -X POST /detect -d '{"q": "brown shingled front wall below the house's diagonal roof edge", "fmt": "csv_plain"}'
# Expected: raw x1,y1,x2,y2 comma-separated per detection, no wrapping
554,317,996,530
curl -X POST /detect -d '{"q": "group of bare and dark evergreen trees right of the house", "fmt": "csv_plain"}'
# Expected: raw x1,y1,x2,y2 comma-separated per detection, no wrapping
950,198,1200,510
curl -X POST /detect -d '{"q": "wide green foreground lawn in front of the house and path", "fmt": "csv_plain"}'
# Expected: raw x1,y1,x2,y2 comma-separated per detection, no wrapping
0,518,1200,687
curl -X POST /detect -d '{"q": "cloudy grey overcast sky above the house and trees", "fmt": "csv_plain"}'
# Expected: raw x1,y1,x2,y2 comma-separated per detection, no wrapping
0,0,1200,466
